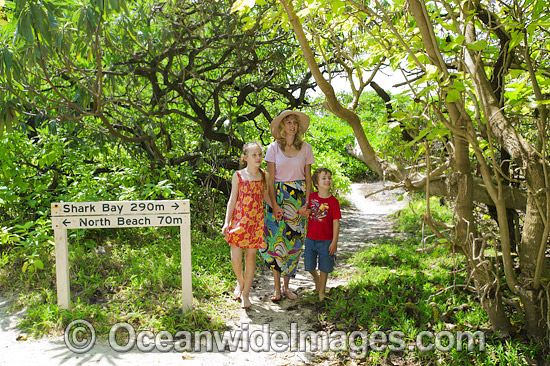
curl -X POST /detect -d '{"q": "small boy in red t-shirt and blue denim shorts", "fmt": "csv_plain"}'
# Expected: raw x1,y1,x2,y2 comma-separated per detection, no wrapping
304,168,342,301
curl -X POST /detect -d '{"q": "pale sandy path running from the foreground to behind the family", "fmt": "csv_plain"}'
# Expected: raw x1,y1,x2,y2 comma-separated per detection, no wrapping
0,183,403,366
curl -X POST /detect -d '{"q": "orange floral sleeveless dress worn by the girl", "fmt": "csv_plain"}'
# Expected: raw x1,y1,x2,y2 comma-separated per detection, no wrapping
225,171,265,249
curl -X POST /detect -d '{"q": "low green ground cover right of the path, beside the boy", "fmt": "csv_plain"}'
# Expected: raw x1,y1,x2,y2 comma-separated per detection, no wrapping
307,196,550,365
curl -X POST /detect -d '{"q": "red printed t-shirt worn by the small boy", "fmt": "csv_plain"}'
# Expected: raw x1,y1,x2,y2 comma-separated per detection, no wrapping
307,192,342,240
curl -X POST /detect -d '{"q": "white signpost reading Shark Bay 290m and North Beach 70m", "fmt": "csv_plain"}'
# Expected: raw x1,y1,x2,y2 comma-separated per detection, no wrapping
51,200,193,312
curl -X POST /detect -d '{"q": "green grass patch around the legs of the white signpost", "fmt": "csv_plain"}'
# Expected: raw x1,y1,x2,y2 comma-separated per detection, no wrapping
0,228,236,336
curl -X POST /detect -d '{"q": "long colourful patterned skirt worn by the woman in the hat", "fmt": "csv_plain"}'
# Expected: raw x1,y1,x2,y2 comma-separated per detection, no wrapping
260,180,307,276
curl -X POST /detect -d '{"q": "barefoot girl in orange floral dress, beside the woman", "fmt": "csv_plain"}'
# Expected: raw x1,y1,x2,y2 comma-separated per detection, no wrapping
222,142,269,309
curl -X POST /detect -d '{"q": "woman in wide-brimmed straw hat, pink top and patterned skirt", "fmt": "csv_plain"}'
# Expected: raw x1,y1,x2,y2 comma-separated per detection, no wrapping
260,110,315,301
